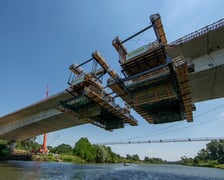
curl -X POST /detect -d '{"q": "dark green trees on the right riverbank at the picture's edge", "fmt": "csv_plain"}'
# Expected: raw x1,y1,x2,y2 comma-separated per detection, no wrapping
180,140,224,168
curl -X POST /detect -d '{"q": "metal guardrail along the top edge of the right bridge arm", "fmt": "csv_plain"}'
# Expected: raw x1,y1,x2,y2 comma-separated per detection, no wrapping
169,18,224,46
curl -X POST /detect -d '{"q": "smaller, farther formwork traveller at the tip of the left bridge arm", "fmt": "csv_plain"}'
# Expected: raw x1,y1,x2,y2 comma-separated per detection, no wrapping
57,51,137,131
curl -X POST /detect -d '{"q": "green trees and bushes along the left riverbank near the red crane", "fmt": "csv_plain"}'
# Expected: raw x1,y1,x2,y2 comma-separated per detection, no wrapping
0,138,165,164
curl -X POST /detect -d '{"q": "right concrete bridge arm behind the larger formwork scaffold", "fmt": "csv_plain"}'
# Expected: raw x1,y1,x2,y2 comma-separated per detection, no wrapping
168,27,224,102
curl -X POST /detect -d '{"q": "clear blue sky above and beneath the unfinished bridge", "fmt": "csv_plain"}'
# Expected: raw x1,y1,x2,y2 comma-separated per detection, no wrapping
0,0,224,160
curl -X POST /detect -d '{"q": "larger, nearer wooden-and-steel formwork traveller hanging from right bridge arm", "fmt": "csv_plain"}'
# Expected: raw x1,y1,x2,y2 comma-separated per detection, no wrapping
108,14,194,124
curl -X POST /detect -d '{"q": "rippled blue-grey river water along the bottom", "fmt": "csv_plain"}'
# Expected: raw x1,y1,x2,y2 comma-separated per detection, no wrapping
0,161,224,180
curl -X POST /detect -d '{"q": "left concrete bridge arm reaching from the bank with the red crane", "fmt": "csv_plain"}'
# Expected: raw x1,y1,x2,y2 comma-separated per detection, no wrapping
0,92,86,141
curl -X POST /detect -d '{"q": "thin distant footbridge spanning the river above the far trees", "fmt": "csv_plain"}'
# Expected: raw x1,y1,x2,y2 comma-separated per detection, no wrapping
97,137,224,145
